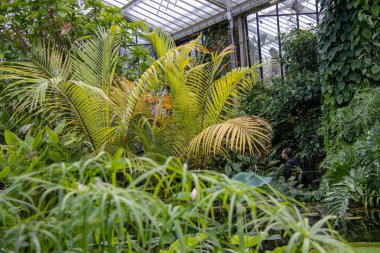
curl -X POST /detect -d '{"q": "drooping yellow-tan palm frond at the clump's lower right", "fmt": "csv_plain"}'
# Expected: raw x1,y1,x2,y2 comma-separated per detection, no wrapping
189,117,272,156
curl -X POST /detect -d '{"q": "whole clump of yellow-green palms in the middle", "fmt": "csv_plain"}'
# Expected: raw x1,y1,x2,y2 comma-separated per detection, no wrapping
0,26,271,162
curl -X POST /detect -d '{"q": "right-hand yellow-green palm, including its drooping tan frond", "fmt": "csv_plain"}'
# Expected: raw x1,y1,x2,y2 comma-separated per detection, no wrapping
137,28,272,164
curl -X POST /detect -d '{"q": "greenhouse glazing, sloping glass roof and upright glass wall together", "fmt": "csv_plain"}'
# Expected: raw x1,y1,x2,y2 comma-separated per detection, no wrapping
103,0,320,78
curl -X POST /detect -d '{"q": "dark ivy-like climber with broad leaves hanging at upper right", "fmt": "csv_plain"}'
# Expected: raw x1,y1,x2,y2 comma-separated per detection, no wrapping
318,0,380,148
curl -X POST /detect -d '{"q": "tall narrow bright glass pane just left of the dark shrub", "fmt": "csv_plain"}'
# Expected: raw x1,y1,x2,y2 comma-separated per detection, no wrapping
259,16,281,78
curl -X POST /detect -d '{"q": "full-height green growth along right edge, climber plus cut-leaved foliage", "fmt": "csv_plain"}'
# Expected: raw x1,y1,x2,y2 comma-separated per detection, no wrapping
318,0,380,220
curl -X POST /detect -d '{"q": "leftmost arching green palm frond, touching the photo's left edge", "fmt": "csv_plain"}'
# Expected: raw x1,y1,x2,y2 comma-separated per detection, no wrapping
0,42,70,124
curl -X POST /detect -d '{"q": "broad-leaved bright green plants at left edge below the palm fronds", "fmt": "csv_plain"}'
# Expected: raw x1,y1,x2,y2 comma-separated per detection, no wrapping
0,121,90,182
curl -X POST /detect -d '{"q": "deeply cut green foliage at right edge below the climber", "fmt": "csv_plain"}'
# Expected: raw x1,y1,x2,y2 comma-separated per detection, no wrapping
321,88,380,223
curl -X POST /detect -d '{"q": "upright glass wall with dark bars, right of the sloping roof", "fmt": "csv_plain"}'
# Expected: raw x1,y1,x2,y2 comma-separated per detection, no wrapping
247,0,319,78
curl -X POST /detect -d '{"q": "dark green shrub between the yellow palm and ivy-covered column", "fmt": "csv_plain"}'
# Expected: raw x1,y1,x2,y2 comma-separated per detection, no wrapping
242,30,324,168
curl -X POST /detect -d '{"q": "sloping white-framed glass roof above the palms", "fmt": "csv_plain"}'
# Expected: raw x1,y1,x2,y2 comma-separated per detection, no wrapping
103,0,280,39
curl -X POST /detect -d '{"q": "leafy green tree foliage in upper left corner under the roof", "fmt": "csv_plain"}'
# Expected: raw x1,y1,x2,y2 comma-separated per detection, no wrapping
0,0,149,79
